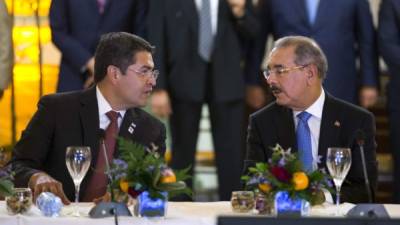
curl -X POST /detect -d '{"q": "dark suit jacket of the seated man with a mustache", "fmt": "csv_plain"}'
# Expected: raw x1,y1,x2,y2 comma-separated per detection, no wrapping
245,94,377,203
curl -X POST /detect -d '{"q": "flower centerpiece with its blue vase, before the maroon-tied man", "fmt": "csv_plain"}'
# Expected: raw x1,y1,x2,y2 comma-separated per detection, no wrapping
110,138,191,217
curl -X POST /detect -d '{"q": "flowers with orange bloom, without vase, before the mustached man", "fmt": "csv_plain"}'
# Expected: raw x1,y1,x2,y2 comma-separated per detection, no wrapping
242,144,332,205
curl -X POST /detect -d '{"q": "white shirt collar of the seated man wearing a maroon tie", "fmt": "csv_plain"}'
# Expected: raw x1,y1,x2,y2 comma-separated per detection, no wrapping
96,86,126,130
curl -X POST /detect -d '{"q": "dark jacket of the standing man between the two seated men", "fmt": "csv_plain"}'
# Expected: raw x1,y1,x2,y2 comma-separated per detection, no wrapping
148,0,258,101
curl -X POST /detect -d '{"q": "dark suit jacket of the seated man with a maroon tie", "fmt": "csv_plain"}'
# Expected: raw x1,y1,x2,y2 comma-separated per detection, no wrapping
11,88,166,199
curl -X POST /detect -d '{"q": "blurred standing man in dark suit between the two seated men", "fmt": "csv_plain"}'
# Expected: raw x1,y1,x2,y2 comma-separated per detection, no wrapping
148,0,258,200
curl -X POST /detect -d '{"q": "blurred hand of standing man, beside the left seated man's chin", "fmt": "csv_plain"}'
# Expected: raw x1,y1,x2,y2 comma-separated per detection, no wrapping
150,90,172,119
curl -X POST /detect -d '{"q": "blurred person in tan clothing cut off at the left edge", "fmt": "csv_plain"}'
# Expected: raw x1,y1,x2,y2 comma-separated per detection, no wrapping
0,0,14,99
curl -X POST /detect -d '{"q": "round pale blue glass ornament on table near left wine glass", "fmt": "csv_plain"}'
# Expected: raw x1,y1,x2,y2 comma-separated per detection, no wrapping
36,192,63,217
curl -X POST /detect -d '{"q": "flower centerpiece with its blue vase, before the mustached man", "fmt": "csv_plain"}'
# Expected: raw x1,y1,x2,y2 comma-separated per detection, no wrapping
242,144,333,216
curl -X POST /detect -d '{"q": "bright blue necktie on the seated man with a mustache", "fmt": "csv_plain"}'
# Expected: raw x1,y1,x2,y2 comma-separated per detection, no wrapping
296,111,313,172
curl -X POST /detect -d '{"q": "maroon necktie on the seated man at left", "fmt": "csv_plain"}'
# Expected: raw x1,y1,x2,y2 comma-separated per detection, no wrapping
83,111,119,202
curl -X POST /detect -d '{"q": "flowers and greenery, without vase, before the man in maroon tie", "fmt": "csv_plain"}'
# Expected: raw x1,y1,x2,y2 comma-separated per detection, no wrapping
110,138,191,200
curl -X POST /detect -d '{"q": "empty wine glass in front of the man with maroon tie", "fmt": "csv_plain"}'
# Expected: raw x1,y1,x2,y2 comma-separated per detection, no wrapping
65,146,92,217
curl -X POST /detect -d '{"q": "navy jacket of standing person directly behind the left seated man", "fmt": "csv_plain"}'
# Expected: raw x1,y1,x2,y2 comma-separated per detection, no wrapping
49,0,146,92
